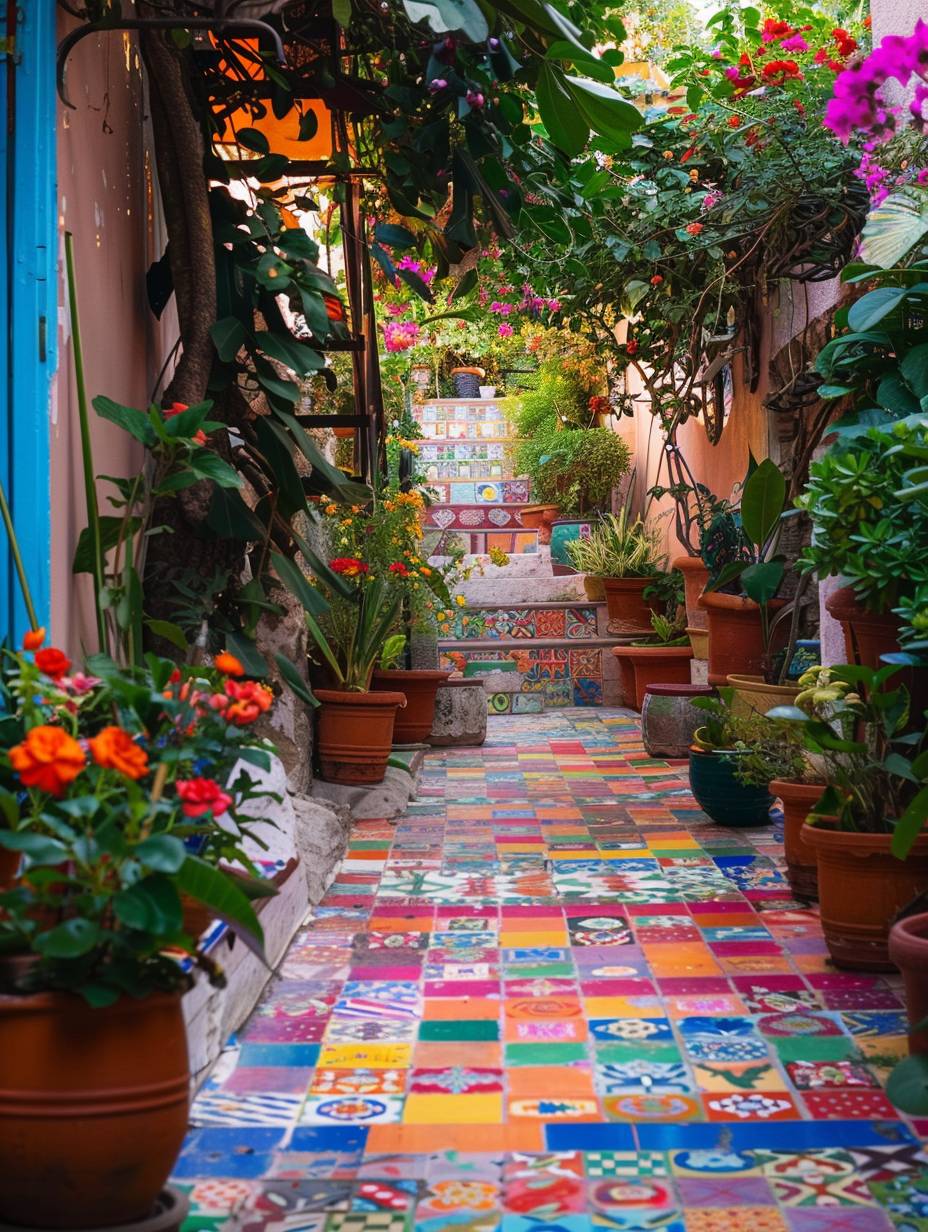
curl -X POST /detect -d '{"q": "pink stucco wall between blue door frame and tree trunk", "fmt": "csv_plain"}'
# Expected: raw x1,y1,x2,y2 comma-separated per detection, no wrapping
51,14,175,652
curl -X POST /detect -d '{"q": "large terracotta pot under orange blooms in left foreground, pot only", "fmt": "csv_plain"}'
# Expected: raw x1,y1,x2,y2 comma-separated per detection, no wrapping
0,993,190,1228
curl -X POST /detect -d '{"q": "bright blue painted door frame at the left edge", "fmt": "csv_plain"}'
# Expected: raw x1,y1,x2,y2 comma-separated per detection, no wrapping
0,0,58,643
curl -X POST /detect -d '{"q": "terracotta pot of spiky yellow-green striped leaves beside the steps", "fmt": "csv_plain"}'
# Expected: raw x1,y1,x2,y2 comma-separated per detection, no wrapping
568,509,667,636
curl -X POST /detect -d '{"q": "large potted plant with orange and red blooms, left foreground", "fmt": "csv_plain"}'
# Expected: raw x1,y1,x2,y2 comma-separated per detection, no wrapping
0,634,269,1228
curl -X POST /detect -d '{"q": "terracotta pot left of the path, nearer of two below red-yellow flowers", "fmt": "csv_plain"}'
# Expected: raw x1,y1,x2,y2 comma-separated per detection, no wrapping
315,689,405,786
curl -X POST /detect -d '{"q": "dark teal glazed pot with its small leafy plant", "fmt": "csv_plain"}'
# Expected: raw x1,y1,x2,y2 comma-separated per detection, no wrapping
690,686,801,827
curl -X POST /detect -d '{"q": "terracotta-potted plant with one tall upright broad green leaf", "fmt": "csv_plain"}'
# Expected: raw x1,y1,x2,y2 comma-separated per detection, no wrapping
700,458,796,715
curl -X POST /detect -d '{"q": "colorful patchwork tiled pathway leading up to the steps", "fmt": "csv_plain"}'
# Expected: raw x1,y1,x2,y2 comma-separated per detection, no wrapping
176,710,928,1232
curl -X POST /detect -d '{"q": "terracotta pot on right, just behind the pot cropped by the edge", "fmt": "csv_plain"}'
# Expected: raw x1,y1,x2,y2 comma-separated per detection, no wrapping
801,822,928,971
